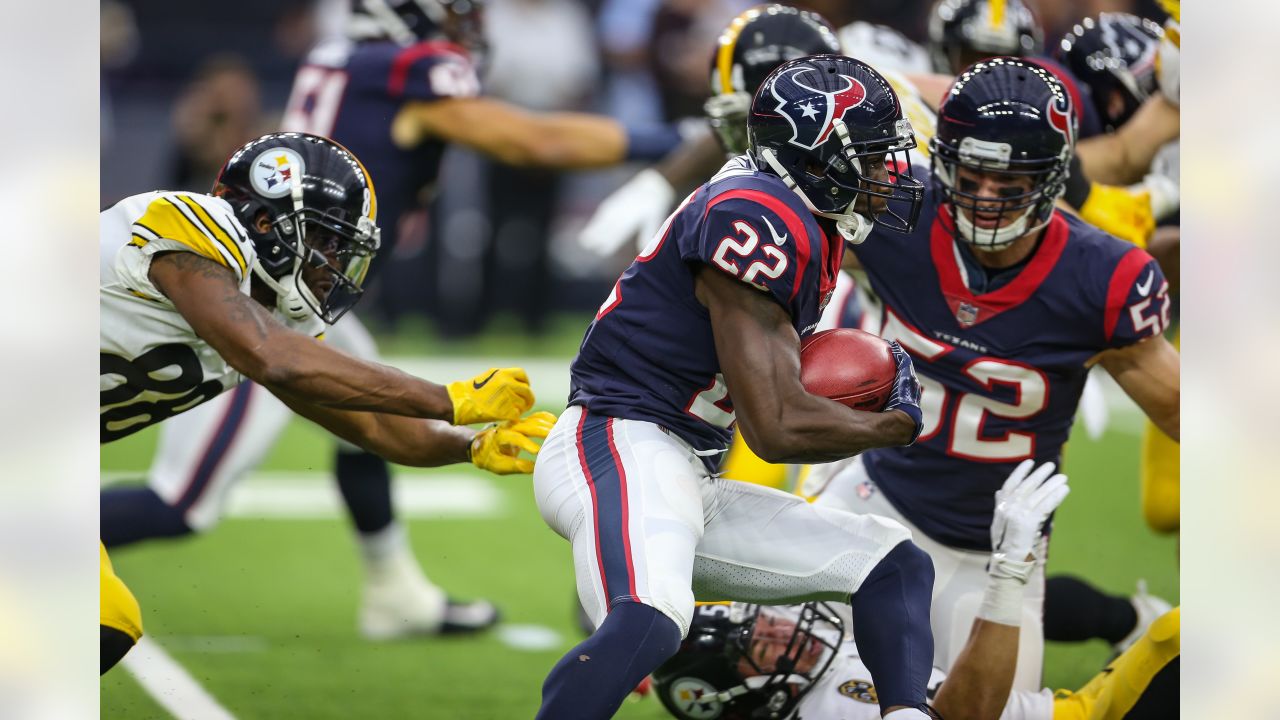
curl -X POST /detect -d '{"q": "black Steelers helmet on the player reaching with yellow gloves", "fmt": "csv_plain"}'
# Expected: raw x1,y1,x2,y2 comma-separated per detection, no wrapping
214,132,381,324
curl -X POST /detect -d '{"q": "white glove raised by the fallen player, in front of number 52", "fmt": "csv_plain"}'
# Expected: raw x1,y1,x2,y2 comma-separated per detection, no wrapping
991,460,1070,562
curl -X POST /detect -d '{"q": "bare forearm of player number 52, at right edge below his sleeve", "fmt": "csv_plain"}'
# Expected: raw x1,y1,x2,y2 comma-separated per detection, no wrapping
1098,337,1181,441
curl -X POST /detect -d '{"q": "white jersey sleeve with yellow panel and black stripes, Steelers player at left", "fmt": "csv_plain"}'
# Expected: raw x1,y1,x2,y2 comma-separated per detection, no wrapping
129,192,255,282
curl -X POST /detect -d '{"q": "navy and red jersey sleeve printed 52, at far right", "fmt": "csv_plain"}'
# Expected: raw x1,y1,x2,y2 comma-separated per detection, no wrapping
1103,247,1170,347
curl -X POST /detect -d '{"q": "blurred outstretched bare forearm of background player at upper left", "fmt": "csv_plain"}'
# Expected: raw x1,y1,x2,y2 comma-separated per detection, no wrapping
411,97,627,169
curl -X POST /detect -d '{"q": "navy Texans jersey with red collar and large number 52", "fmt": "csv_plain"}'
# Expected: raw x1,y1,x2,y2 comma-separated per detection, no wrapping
856,183,1170,551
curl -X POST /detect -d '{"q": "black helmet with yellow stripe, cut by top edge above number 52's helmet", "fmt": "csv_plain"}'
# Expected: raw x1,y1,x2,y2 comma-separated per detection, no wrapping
928,0,1044,76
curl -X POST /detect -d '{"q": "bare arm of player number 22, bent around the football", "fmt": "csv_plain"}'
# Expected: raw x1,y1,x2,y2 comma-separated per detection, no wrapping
695,268,914,462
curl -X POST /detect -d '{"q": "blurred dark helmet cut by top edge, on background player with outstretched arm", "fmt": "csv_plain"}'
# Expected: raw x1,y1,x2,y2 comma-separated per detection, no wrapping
347,0,488,56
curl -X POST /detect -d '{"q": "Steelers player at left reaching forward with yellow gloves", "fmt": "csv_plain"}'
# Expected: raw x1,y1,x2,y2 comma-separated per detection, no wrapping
99,133,554,671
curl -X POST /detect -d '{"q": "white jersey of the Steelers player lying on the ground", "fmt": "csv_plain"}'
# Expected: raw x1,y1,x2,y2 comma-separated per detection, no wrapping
790,639,1053,720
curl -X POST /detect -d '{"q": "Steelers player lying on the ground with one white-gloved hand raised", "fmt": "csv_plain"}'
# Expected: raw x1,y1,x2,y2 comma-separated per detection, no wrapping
653,460,1180,720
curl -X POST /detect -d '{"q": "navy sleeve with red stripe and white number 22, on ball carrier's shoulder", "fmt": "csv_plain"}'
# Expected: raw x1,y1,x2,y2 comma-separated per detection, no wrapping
680,190,822,315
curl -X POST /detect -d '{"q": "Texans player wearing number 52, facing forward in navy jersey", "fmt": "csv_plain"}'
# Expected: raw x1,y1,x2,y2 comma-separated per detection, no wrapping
804,58,1179,691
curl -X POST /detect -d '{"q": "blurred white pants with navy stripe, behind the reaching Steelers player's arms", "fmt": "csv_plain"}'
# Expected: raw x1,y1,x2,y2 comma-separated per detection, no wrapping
147,313,378,532
